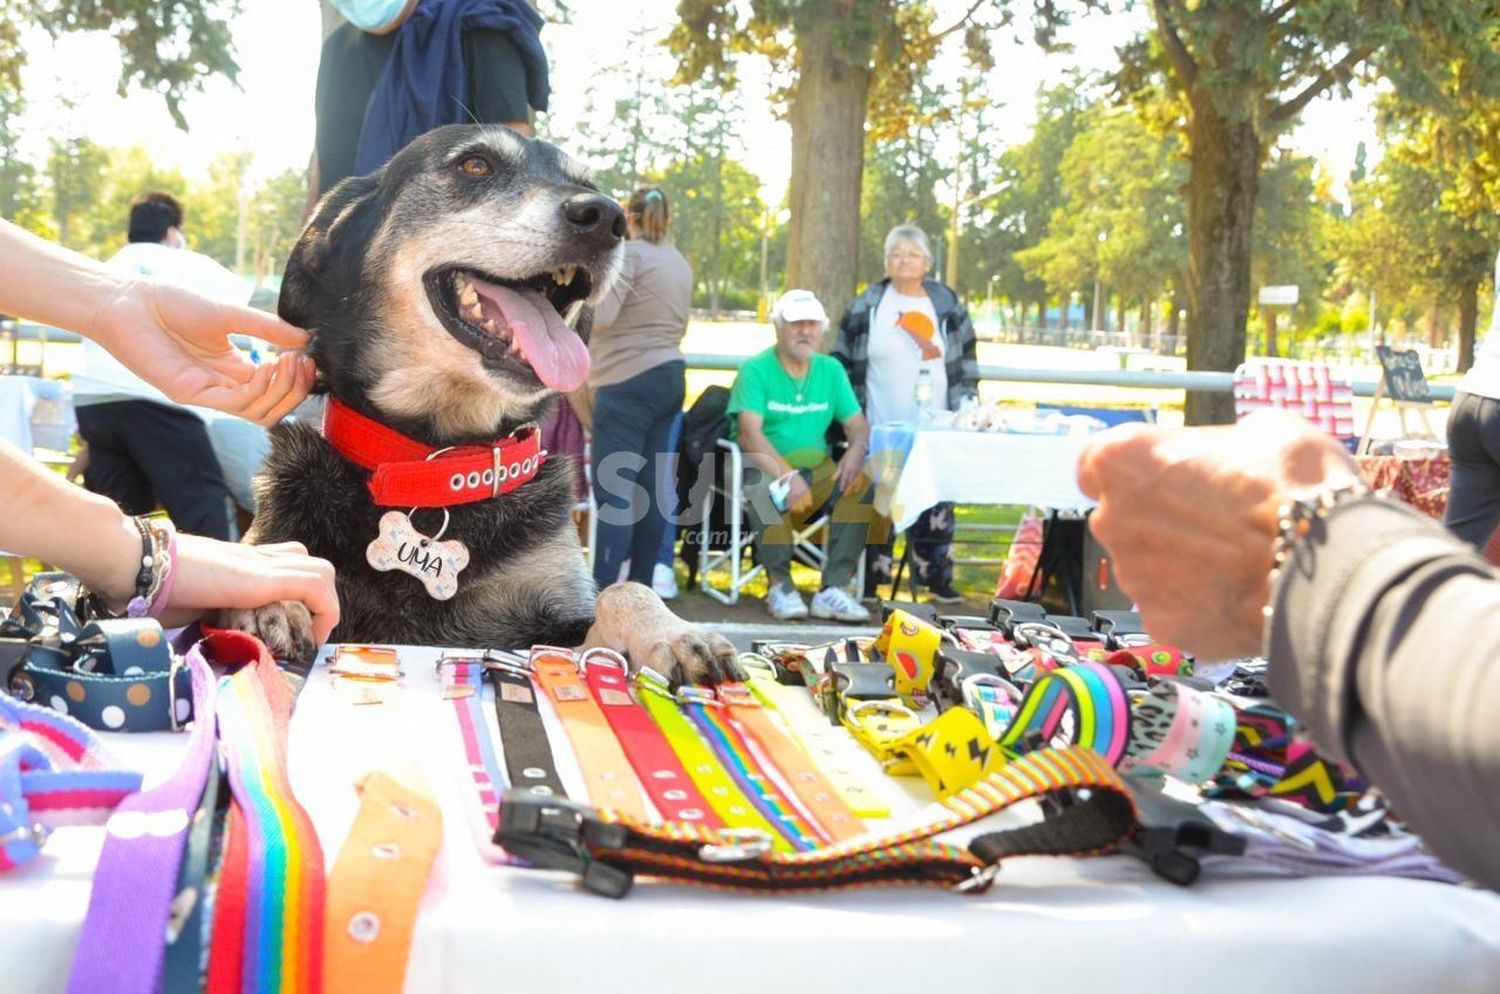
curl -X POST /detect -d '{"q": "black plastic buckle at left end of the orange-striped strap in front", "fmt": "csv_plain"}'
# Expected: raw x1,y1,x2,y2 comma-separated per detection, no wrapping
495,790,635,898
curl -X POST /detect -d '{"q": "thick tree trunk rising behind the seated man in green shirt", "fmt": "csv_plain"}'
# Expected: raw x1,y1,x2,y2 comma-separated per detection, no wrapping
786,10,873,351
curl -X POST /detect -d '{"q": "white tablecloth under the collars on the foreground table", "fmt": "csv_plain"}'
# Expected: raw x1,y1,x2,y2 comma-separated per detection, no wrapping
0,649,1500,994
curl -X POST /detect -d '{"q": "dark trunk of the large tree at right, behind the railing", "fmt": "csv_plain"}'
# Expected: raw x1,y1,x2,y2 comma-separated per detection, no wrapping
1185,85,1262,424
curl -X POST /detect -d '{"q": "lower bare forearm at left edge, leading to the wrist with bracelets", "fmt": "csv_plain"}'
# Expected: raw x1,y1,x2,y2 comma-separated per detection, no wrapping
0,439,141,604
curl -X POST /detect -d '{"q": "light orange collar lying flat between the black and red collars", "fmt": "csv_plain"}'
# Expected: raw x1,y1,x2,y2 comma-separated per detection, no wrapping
531,646,647,819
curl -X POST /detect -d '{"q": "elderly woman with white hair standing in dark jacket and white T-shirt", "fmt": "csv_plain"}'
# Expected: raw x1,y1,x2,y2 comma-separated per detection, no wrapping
833,225,980,604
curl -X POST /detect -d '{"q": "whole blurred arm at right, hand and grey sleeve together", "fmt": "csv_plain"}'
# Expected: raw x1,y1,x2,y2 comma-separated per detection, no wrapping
1079,412,1500,888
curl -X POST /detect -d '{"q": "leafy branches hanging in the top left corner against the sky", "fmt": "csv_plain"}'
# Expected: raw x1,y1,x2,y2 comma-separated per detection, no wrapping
0,0,240,129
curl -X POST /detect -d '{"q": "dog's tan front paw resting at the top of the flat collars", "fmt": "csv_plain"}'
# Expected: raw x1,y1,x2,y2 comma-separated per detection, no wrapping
584,583,746,687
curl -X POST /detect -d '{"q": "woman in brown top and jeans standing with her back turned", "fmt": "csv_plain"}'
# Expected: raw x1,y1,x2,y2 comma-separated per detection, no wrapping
585,186,693,589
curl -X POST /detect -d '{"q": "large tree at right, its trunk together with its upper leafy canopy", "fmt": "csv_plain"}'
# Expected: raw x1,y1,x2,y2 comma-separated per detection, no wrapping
1041,0,1500,423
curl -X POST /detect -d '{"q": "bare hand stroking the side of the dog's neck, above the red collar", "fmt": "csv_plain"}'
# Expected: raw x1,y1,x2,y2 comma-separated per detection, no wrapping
92,280,315,424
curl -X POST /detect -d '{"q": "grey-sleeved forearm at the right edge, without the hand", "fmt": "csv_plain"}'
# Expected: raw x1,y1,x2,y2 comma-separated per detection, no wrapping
1266,502,1500,886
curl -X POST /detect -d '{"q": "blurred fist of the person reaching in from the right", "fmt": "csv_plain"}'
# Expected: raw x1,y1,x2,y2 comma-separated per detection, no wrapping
1079,411,1359,660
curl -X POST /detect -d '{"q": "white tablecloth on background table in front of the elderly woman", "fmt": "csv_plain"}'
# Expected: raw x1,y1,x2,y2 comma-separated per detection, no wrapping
870,424,1094,531
